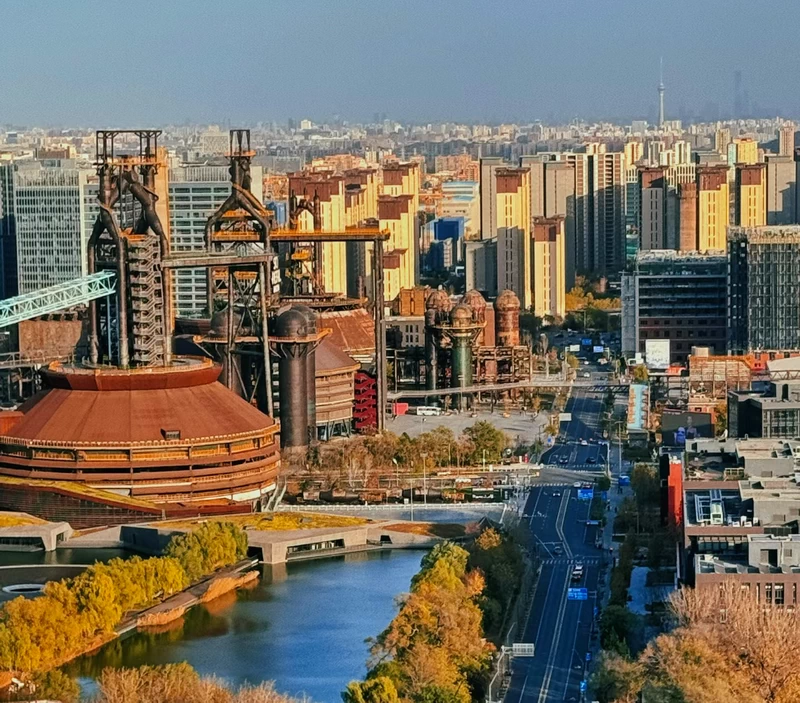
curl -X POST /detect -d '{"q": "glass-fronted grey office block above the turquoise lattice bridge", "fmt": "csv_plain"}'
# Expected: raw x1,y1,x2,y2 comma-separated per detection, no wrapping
13,161,91,293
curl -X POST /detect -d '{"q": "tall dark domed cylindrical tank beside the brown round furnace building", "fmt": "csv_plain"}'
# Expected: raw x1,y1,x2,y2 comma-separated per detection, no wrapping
275,308,308,448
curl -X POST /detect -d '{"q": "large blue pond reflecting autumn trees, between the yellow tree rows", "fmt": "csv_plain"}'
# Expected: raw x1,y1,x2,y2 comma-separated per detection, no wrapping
65,550,423,703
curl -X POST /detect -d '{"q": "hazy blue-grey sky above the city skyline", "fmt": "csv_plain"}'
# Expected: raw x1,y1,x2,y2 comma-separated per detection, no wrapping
0,0,800,127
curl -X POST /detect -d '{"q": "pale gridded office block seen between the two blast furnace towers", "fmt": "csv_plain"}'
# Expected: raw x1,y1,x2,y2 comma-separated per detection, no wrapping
170,162,263,317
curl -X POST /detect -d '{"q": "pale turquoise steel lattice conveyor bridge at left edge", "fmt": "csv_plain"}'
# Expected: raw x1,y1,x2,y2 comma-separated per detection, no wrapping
0,271,117,328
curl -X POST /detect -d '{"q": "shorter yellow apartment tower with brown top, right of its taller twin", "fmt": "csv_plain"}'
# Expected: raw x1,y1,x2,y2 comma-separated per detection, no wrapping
531,216,567,319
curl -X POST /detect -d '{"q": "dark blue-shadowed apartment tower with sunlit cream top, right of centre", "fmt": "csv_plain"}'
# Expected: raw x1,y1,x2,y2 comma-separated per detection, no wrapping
590,152,625,275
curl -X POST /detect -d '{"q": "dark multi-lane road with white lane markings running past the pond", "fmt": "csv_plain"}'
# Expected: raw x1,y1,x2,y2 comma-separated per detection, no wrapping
505,390,616,703
